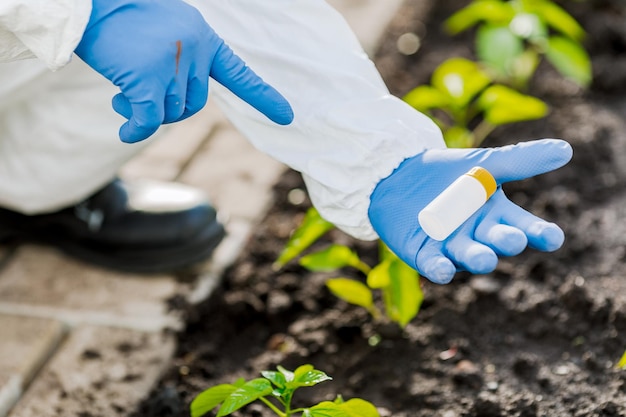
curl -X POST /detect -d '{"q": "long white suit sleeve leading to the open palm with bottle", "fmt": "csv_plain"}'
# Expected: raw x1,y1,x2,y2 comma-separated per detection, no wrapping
196,0,445,240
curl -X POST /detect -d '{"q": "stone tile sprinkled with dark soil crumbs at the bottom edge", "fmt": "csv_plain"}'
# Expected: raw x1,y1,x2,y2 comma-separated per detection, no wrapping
9,326,175,417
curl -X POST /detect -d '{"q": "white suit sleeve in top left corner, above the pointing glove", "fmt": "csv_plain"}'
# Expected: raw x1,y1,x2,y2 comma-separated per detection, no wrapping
0,0,91,70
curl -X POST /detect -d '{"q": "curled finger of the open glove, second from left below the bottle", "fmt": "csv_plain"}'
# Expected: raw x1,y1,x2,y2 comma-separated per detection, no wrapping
444,229,498,274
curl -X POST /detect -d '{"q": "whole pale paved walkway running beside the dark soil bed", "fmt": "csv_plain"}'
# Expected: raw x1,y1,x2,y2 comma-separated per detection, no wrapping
0,0,402,417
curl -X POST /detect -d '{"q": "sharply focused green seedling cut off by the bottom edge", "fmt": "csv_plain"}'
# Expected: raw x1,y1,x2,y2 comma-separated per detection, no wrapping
190,365,380,417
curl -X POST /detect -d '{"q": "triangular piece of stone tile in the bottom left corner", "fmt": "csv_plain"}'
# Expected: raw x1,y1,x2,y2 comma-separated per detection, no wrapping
0,314,64,417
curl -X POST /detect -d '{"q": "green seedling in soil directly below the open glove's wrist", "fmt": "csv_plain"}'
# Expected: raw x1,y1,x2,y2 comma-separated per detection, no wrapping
275,208,423,327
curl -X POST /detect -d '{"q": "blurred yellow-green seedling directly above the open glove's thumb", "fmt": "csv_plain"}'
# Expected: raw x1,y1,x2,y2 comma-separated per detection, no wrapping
404,58,548,148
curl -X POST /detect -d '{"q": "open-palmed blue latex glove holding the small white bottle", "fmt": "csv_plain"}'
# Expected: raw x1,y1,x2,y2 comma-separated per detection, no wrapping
369,139,572,284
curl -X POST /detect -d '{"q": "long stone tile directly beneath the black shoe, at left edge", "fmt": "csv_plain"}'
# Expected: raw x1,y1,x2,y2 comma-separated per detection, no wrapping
0,245,183,330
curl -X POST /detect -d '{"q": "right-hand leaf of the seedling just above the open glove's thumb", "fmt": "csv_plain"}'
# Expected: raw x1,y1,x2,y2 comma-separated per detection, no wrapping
478,85,548,125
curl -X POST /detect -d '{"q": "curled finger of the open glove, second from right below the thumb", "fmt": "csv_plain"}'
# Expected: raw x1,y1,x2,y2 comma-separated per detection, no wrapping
474,190,528,256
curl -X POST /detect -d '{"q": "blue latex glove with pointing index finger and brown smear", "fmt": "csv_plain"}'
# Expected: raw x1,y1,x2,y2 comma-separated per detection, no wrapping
75,0,293,143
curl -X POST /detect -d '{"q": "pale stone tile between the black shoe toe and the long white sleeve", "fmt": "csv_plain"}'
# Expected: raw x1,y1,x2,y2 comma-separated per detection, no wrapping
180,125,285,221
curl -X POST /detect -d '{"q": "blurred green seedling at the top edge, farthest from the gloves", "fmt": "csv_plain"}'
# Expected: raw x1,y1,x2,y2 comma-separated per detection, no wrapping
444,0,592,90
